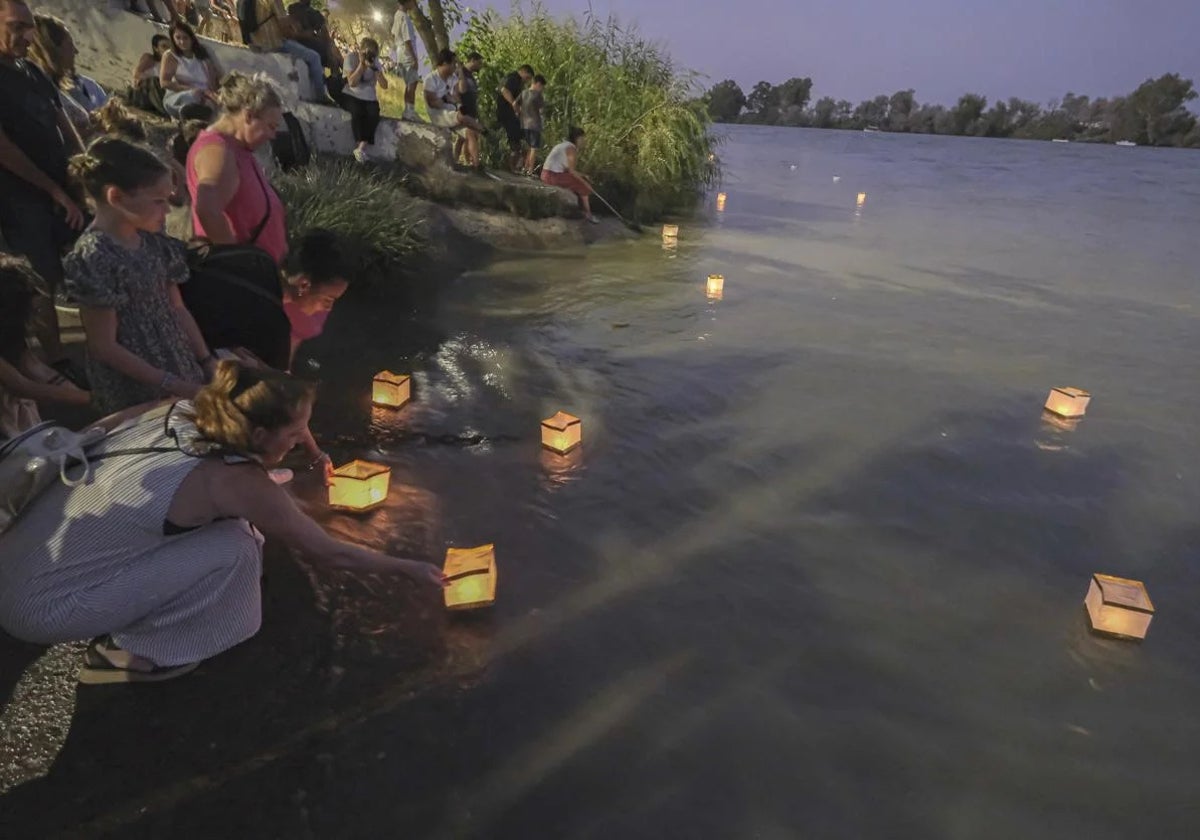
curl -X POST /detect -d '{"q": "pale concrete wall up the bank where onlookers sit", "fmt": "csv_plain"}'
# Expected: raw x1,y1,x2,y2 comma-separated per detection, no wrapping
37,0,452,168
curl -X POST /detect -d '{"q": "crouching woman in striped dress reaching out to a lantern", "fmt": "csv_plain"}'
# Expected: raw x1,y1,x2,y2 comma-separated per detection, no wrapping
0,361,442,683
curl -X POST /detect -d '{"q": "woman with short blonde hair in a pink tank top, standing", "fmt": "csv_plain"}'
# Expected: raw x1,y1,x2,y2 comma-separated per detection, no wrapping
187,73,288,264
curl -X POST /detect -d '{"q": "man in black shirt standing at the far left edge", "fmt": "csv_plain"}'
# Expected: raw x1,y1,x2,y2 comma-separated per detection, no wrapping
0,0,84,376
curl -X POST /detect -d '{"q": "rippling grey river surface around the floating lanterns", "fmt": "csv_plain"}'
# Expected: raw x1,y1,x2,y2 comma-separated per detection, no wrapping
304,127,1200,839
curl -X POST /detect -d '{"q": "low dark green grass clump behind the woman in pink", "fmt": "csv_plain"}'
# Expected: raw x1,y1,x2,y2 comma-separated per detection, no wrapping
272,157,427,282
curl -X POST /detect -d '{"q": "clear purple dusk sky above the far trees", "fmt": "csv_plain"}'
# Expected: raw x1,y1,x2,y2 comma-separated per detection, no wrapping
530,0,1200,103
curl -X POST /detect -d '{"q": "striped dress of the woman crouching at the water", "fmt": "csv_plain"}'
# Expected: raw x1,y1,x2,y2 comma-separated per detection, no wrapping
0,402,263,666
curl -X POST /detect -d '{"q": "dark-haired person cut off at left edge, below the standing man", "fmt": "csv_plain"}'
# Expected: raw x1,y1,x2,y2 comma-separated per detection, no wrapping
0,253,91,439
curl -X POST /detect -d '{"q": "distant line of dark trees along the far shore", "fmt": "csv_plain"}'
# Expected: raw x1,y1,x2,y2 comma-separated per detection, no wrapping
704,73,1200,149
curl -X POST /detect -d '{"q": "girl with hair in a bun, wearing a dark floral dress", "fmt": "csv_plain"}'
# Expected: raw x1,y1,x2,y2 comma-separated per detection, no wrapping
64,137,216,413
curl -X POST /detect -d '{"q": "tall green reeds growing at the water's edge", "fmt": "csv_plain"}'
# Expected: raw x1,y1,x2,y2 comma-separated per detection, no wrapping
458,0,716,218
